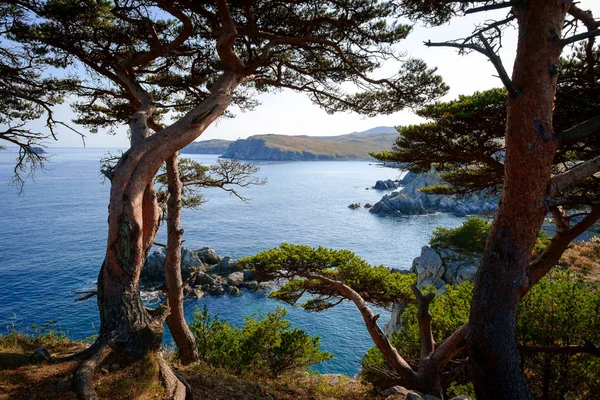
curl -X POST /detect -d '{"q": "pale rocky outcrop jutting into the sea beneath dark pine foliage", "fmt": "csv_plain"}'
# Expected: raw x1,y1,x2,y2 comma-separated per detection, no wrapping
369,172,499,217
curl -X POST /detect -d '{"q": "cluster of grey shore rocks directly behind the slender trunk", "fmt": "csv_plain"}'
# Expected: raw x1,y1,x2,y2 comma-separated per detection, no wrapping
140,247,267,298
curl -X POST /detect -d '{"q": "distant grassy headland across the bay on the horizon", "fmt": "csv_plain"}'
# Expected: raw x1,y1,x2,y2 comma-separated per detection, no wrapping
221,132,398,161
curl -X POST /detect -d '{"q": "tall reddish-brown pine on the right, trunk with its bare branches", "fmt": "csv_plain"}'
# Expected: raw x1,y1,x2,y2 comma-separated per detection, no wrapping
382,0,600,399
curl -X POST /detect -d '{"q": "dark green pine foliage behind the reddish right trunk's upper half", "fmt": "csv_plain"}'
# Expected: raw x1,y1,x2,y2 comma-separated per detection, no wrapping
373,47,600,205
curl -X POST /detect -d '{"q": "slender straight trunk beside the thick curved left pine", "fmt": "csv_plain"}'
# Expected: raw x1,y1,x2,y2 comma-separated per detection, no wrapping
165,153,199,365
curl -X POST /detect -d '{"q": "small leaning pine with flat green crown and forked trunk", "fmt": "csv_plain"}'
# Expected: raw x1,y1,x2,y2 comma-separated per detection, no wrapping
240,243,468,397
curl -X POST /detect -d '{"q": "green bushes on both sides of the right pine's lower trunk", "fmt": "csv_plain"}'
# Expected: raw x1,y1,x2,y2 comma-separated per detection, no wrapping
361,269,600,400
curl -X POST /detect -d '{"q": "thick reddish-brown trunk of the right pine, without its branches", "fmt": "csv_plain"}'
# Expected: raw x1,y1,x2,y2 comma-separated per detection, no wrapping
468,0,571,400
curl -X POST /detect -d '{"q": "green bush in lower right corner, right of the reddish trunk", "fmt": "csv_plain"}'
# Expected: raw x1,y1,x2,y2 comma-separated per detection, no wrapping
517,270,600,399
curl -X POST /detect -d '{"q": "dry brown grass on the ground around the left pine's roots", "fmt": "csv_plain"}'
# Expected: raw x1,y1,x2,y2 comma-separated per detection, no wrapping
0,334,382,400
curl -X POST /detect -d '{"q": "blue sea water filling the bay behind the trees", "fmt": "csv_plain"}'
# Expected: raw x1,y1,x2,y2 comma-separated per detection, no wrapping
0,148,463,375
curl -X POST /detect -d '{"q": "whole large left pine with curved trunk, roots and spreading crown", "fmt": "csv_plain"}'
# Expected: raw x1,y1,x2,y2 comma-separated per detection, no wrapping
6,0,446,398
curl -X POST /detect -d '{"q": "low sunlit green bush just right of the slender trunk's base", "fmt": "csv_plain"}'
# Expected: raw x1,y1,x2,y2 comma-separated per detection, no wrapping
190,307,333,377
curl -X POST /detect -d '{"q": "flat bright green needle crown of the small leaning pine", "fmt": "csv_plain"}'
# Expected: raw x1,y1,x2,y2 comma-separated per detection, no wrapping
240,243,415,311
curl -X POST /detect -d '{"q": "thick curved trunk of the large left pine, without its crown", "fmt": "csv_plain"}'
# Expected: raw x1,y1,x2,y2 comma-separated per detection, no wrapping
98,72,240,358
